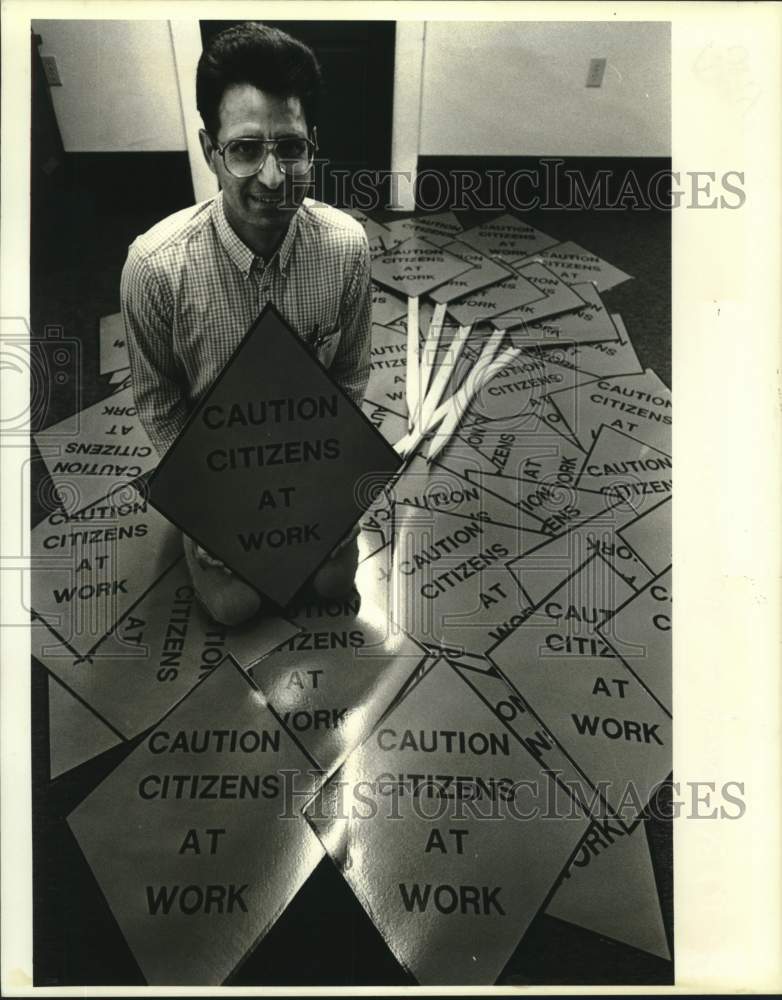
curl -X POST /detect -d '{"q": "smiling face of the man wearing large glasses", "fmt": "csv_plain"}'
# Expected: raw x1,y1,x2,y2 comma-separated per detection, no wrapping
201,84,309,239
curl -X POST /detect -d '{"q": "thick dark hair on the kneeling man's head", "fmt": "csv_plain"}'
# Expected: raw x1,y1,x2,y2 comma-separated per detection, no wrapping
196,21,321,138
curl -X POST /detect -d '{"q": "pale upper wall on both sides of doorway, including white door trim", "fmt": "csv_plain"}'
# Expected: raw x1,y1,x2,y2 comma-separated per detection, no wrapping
33,19,670,197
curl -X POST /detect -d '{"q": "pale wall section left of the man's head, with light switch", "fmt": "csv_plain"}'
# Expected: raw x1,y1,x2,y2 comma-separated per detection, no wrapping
32,20,186,153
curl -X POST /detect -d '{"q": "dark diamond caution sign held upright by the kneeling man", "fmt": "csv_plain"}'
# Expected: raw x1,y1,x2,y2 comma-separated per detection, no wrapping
150,305,400,605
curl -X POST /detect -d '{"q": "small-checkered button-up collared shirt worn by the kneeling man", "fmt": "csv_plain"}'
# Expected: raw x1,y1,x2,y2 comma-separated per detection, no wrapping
120,193,371,456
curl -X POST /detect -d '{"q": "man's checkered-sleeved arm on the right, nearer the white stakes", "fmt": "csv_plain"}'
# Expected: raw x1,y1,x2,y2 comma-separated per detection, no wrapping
330,233,372,407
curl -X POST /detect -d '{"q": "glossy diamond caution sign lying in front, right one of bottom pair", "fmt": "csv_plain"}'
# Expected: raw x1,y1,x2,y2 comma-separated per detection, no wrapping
305,660,587,985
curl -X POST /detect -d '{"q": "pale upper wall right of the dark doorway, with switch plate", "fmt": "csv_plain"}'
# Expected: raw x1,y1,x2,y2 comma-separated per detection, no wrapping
418,21,670,156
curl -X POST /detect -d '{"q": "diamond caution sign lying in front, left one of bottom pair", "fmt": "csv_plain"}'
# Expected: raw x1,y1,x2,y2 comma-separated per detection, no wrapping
68,659,323,986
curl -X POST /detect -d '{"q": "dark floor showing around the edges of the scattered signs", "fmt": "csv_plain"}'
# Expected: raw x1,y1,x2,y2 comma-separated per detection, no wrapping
31,164,673,986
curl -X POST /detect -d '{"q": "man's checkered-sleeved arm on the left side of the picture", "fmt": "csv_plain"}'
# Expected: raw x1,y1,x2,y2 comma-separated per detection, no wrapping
120,245,187,458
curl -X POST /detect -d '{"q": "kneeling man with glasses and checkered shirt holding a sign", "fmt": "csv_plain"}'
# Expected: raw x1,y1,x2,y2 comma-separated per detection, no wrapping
121,23,371,625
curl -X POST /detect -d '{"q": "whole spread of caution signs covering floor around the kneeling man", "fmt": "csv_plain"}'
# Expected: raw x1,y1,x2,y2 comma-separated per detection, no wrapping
38,212,672,985
